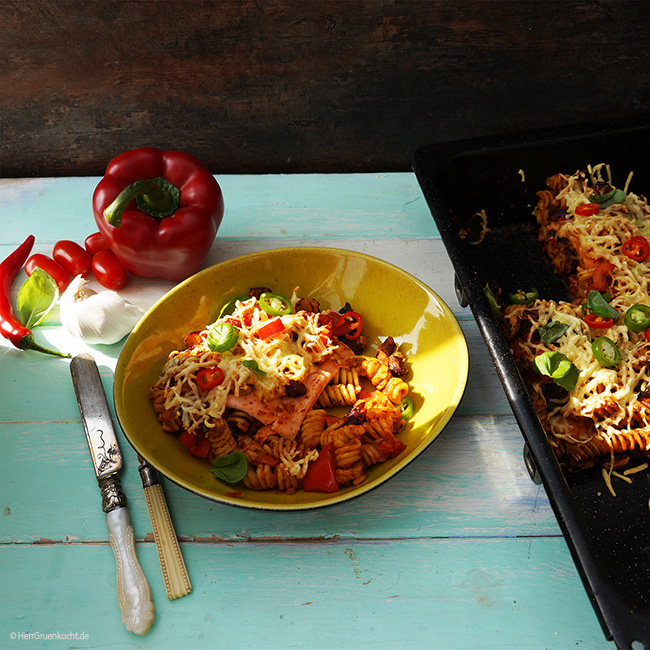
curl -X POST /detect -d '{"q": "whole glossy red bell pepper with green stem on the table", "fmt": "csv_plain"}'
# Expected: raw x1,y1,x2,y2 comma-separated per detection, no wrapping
93,147,223,282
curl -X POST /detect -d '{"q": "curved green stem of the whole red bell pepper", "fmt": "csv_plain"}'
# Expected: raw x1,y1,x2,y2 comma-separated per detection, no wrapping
104,178,180,228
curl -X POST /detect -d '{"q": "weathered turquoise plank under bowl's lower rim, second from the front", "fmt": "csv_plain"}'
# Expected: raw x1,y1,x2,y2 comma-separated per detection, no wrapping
0,416,560,544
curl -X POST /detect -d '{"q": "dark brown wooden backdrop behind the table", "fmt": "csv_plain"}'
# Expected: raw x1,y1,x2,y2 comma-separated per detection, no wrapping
0,0,650,177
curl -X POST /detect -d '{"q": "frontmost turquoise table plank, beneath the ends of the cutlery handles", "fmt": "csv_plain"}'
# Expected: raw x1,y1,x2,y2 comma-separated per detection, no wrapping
0,539,611,650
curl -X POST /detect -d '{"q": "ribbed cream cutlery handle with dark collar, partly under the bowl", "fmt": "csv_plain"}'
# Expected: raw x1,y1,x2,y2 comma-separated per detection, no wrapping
138,455,192,600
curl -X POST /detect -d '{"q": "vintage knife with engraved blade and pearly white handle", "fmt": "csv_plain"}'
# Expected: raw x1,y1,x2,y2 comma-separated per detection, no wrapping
70,354,156,634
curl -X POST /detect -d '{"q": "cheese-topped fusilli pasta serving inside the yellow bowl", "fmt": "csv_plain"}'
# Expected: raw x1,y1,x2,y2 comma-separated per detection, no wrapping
151,287,413,494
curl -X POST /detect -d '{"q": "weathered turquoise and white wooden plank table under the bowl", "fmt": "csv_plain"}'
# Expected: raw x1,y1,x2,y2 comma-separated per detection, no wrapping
0,173,613,650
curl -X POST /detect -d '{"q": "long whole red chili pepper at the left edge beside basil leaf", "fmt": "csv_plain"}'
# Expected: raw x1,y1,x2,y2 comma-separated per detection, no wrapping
0,235,70,357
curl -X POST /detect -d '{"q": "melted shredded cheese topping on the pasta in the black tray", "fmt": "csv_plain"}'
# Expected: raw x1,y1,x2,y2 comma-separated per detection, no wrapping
504,165,650,460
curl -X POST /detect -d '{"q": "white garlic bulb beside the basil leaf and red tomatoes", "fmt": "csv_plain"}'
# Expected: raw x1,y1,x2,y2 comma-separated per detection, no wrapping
59,275,144,345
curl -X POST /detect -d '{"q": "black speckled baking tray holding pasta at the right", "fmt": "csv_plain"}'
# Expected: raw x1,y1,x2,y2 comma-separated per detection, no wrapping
413,115,650,650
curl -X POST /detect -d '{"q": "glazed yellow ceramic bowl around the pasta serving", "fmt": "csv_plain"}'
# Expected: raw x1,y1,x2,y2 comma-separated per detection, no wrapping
114,247,469,510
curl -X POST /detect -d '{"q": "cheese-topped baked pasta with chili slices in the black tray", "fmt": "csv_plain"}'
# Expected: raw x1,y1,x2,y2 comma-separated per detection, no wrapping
488,165,650,490
